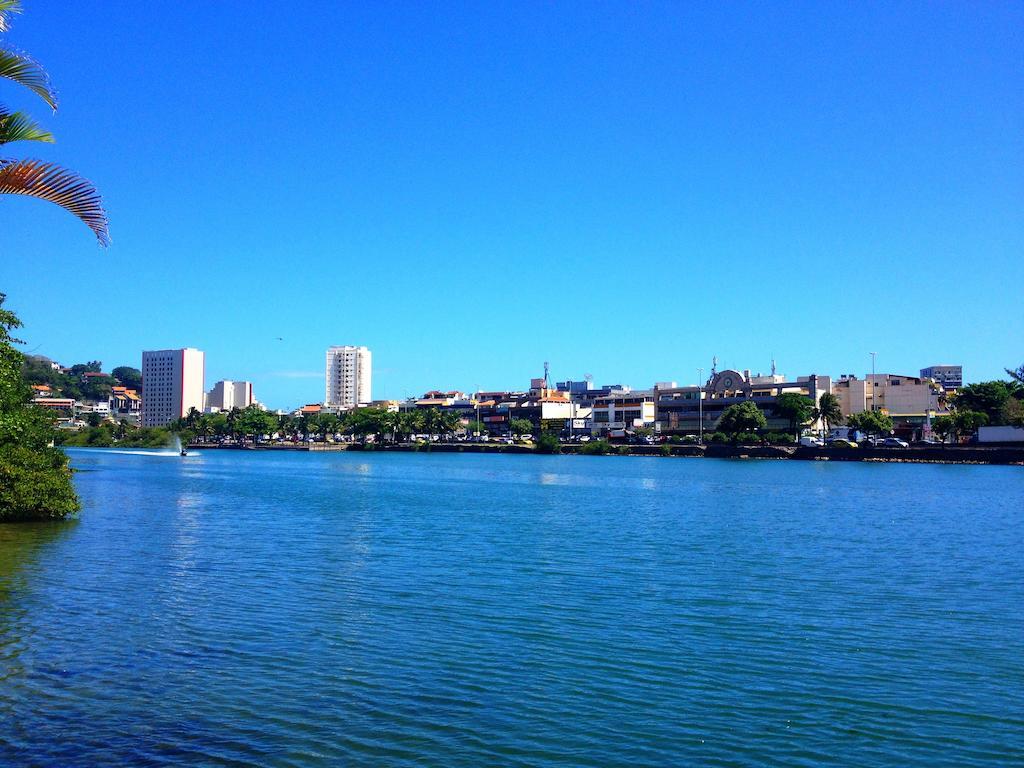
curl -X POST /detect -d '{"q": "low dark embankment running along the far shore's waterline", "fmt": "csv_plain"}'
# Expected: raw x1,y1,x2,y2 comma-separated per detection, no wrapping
188,442,1024,466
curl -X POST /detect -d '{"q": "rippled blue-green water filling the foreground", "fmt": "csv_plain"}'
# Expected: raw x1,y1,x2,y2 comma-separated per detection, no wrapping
0,451,1024,767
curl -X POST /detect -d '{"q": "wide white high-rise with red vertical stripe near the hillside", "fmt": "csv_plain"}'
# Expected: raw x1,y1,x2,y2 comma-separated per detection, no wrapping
142,347,206,427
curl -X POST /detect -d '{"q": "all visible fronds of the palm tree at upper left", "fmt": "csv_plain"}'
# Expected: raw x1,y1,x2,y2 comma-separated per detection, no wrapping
0,0,110,241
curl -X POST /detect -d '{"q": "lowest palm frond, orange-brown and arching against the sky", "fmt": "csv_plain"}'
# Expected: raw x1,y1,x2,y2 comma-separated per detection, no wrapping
0,160,111,246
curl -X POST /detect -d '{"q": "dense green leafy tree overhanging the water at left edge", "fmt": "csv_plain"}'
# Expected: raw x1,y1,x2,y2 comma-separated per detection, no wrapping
0,294,79,522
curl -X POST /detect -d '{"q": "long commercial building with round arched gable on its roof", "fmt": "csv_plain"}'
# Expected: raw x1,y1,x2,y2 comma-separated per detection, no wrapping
654,369,831,434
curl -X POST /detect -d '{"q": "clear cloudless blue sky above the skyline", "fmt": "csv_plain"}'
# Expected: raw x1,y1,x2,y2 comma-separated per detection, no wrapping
0,0,1024,408
